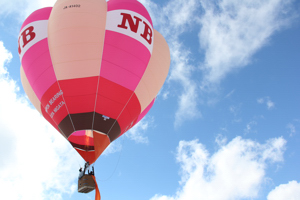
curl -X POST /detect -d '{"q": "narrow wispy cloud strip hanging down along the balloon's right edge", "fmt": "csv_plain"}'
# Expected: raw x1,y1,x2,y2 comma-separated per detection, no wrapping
141,0,201,126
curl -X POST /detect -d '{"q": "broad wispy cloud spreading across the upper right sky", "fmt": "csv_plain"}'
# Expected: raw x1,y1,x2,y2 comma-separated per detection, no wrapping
142,0,294,125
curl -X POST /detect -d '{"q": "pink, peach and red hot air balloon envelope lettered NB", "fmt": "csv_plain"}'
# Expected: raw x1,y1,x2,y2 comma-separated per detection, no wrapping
18,0,170,199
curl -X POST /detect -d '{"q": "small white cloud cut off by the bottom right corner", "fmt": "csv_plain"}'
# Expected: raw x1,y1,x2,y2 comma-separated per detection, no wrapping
267,181,300,200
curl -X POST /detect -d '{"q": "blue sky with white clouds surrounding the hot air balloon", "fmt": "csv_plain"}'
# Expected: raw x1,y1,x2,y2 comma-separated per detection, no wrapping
0,0,300,200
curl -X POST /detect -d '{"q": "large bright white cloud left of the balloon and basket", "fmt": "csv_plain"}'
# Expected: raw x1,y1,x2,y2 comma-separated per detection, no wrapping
0,42,82,200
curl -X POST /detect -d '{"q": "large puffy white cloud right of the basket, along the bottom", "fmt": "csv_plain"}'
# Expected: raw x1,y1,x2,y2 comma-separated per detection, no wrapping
151,137,286,200
